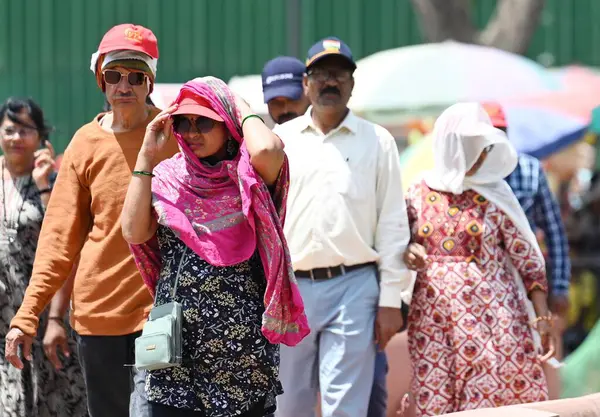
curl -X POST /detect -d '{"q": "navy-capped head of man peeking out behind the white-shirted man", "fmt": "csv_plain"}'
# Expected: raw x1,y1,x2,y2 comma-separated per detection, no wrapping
262,56,310,124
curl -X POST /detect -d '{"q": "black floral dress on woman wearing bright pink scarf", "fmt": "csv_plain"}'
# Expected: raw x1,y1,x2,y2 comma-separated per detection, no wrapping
146,226,283,417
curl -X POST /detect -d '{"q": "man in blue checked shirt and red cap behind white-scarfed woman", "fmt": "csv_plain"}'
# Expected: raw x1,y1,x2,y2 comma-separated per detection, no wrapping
483,103,571,358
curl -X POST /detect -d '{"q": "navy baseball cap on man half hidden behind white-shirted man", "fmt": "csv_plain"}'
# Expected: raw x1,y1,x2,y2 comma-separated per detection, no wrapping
262,56,306,103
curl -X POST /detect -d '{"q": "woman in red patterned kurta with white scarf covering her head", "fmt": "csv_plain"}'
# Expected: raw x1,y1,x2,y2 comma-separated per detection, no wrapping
405,103,554,415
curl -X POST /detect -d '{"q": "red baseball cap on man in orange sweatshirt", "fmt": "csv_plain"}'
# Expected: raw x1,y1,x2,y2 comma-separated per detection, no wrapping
98,23,158,59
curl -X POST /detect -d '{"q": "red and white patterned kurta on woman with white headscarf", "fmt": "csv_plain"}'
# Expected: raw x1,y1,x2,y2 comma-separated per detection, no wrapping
407,182,548,416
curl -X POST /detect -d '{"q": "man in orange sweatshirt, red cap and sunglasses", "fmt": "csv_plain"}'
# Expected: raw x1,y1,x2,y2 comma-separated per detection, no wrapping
6,24,177,417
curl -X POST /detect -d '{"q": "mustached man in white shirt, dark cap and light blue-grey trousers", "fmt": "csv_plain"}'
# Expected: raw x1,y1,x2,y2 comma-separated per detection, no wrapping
276,38,411,417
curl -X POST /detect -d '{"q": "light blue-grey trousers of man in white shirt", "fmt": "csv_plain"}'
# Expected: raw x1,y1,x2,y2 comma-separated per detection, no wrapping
275,266,379,417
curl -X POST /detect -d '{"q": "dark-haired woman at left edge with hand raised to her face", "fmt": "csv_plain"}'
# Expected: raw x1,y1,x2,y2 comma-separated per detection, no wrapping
0,97,87,417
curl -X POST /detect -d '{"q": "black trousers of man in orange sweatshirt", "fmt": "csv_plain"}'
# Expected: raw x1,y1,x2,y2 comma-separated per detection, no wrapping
76,333,150,417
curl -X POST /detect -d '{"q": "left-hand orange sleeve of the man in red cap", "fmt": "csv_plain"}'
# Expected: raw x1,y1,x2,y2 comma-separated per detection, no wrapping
10,138,92,336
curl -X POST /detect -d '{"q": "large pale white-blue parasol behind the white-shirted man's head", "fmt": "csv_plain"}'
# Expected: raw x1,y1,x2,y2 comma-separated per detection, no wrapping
350,41,560,113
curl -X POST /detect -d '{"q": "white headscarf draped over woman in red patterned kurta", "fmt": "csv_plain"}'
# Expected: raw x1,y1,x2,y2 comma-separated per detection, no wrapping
425,103,543,259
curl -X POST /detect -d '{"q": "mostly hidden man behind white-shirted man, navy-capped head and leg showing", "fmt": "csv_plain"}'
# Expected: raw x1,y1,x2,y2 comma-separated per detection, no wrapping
262,56,388,417
